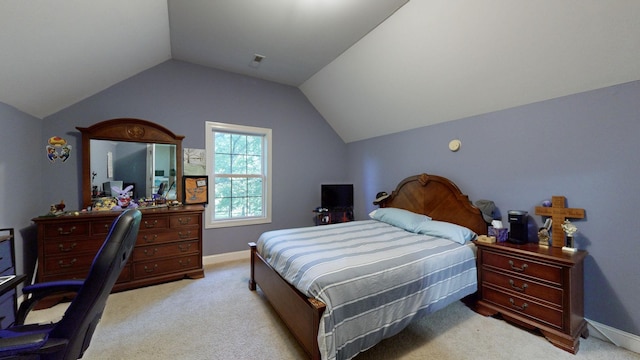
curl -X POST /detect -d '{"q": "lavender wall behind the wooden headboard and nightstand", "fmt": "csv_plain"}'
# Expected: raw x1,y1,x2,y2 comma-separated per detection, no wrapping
347,81,640,335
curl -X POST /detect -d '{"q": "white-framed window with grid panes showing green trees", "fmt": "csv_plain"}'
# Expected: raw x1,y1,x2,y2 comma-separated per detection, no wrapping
205,121,271,228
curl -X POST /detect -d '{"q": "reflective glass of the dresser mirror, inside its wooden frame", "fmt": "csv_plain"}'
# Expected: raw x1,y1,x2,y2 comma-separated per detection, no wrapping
90,139,177,200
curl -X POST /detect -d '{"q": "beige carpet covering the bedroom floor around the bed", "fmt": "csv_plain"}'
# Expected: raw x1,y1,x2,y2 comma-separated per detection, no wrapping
28,260,640,360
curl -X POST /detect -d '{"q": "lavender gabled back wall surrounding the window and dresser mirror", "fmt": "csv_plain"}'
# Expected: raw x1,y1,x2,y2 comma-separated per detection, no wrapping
40,61,347,255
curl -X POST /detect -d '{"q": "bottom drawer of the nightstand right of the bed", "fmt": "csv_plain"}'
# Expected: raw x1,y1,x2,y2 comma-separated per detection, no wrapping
482,285,563,330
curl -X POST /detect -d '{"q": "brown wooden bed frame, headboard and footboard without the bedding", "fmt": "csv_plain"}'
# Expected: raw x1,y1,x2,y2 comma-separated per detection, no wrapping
249,174,487,360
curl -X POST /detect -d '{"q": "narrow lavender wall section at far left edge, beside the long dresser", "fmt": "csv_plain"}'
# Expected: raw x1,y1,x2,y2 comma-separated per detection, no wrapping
0,102,42,273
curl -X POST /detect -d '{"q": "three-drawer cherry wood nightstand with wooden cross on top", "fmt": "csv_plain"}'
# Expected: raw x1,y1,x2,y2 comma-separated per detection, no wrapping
476,242,589,354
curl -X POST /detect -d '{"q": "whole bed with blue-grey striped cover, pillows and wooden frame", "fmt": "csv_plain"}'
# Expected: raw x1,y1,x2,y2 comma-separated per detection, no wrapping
249,174,487,360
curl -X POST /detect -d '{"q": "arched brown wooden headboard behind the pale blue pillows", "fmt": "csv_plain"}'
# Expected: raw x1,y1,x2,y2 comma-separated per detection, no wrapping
380,174,487,235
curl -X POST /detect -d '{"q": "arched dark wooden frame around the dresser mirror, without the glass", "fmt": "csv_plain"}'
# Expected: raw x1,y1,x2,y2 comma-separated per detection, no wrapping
76,118,184,209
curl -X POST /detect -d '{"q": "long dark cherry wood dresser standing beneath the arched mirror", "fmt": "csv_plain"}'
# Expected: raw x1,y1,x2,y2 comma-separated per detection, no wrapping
33,205,204,305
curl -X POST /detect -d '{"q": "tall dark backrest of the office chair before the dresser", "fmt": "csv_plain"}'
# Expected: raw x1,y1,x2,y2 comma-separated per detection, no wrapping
50,209,142,360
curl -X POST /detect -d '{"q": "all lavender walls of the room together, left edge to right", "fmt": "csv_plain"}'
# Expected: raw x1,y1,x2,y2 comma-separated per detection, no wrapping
6,61,640,334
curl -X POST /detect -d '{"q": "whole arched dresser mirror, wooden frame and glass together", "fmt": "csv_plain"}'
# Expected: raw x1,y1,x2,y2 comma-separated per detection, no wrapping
77,118,184,208
